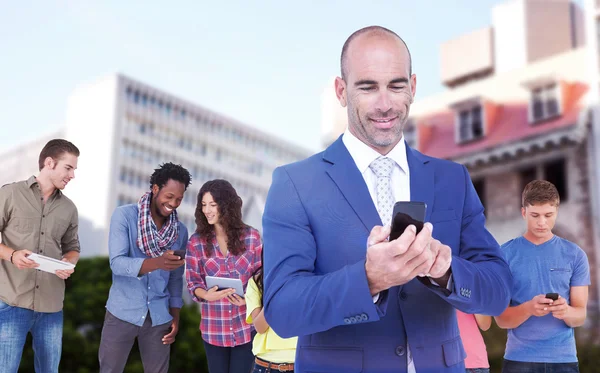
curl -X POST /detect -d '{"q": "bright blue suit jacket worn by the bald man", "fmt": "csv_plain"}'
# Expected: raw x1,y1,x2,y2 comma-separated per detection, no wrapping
263,137,512,373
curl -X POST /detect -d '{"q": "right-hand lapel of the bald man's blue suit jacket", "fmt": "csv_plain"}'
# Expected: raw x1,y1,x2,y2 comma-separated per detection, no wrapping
406,146,434,221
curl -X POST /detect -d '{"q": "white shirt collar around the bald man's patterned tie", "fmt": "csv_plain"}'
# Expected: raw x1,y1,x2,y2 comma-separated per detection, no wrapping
342,129,408,174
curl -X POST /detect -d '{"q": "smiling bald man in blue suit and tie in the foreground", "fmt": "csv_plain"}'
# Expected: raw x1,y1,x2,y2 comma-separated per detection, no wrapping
263,26,512,373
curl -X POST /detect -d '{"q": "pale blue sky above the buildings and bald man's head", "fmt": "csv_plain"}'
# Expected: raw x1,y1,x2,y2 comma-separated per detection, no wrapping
0,0,536,151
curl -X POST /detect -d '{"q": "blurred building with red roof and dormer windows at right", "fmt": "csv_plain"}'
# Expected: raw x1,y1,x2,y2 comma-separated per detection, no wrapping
324,0,600,311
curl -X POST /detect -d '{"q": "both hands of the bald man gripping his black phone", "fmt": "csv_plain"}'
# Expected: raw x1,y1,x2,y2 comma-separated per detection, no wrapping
365,223,436,295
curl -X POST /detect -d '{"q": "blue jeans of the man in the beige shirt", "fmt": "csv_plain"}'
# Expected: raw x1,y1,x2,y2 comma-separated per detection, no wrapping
0,301,63,373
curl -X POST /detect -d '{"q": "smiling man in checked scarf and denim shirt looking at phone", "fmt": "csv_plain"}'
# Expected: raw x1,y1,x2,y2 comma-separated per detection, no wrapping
98,163,191,373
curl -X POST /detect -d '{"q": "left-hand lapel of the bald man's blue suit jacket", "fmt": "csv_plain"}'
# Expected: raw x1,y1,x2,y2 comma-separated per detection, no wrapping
323,136,381,232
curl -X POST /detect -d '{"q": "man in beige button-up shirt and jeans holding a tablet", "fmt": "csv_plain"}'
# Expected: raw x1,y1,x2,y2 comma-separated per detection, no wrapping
0,139,80,373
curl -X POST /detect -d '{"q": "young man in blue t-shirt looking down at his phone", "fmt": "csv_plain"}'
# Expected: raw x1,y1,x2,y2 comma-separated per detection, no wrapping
496,180,590,373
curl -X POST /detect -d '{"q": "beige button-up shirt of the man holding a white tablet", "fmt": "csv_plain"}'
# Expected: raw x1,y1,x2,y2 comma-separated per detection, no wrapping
0,176,80,312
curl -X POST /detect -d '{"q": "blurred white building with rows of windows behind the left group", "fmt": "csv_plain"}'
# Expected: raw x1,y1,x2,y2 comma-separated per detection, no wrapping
0,75,310,256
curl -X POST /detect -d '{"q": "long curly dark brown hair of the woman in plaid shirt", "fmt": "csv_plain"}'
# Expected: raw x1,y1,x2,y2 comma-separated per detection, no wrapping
194,179,248,257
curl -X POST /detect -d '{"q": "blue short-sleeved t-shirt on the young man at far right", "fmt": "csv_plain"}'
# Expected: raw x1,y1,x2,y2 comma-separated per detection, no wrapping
501,236,590,363
